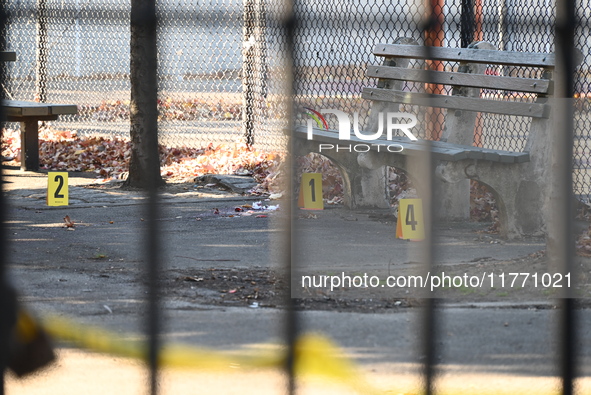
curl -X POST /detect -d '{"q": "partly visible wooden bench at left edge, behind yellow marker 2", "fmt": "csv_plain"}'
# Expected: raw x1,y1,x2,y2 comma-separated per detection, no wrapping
2,100,78,171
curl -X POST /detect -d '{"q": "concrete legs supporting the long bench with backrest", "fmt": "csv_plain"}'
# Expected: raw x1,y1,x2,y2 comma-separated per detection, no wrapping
295,133,548,239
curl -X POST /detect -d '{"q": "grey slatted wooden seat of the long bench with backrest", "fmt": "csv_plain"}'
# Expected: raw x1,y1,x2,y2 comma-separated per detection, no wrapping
295,126,529,163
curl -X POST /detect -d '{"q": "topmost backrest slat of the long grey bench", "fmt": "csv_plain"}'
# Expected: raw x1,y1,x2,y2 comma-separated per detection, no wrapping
373,44,555,67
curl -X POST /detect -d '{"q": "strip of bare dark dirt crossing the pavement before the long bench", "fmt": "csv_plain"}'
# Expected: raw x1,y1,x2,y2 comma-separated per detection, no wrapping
164,252,591,313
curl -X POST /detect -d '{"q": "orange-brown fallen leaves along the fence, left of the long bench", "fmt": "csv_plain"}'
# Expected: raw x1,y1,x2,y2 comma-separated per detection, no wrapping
2,129,283,193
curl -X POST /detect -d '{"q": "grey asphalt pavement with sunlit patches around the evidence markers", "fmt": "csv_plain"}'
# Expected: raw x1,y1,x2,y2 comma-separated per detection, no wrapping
5,171,591,394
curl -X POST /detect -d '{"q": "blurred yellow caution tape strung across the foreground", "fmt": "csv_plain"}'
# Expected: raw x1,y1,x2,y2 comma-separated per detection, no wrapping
42,316,379,394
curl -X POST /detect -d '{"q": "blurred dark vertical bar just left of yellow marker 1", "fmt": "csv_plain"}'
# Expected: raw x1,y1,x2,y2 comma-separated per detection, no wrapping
281,0,299,395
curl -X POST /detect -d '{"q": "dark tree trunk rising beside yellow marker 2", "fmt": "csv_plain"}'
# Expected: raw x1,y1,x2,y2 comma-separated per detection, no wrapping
126,0,164,188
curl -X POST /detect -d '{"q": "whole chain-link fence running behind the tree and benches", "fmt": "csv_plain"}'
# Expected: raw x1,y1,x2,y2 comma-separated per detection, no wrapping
4,0,591,200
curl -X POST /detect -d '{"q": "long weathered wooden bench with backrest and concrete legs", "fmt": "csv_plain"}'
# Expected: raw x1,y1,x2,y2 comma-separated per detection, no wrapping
295,38,568,238
